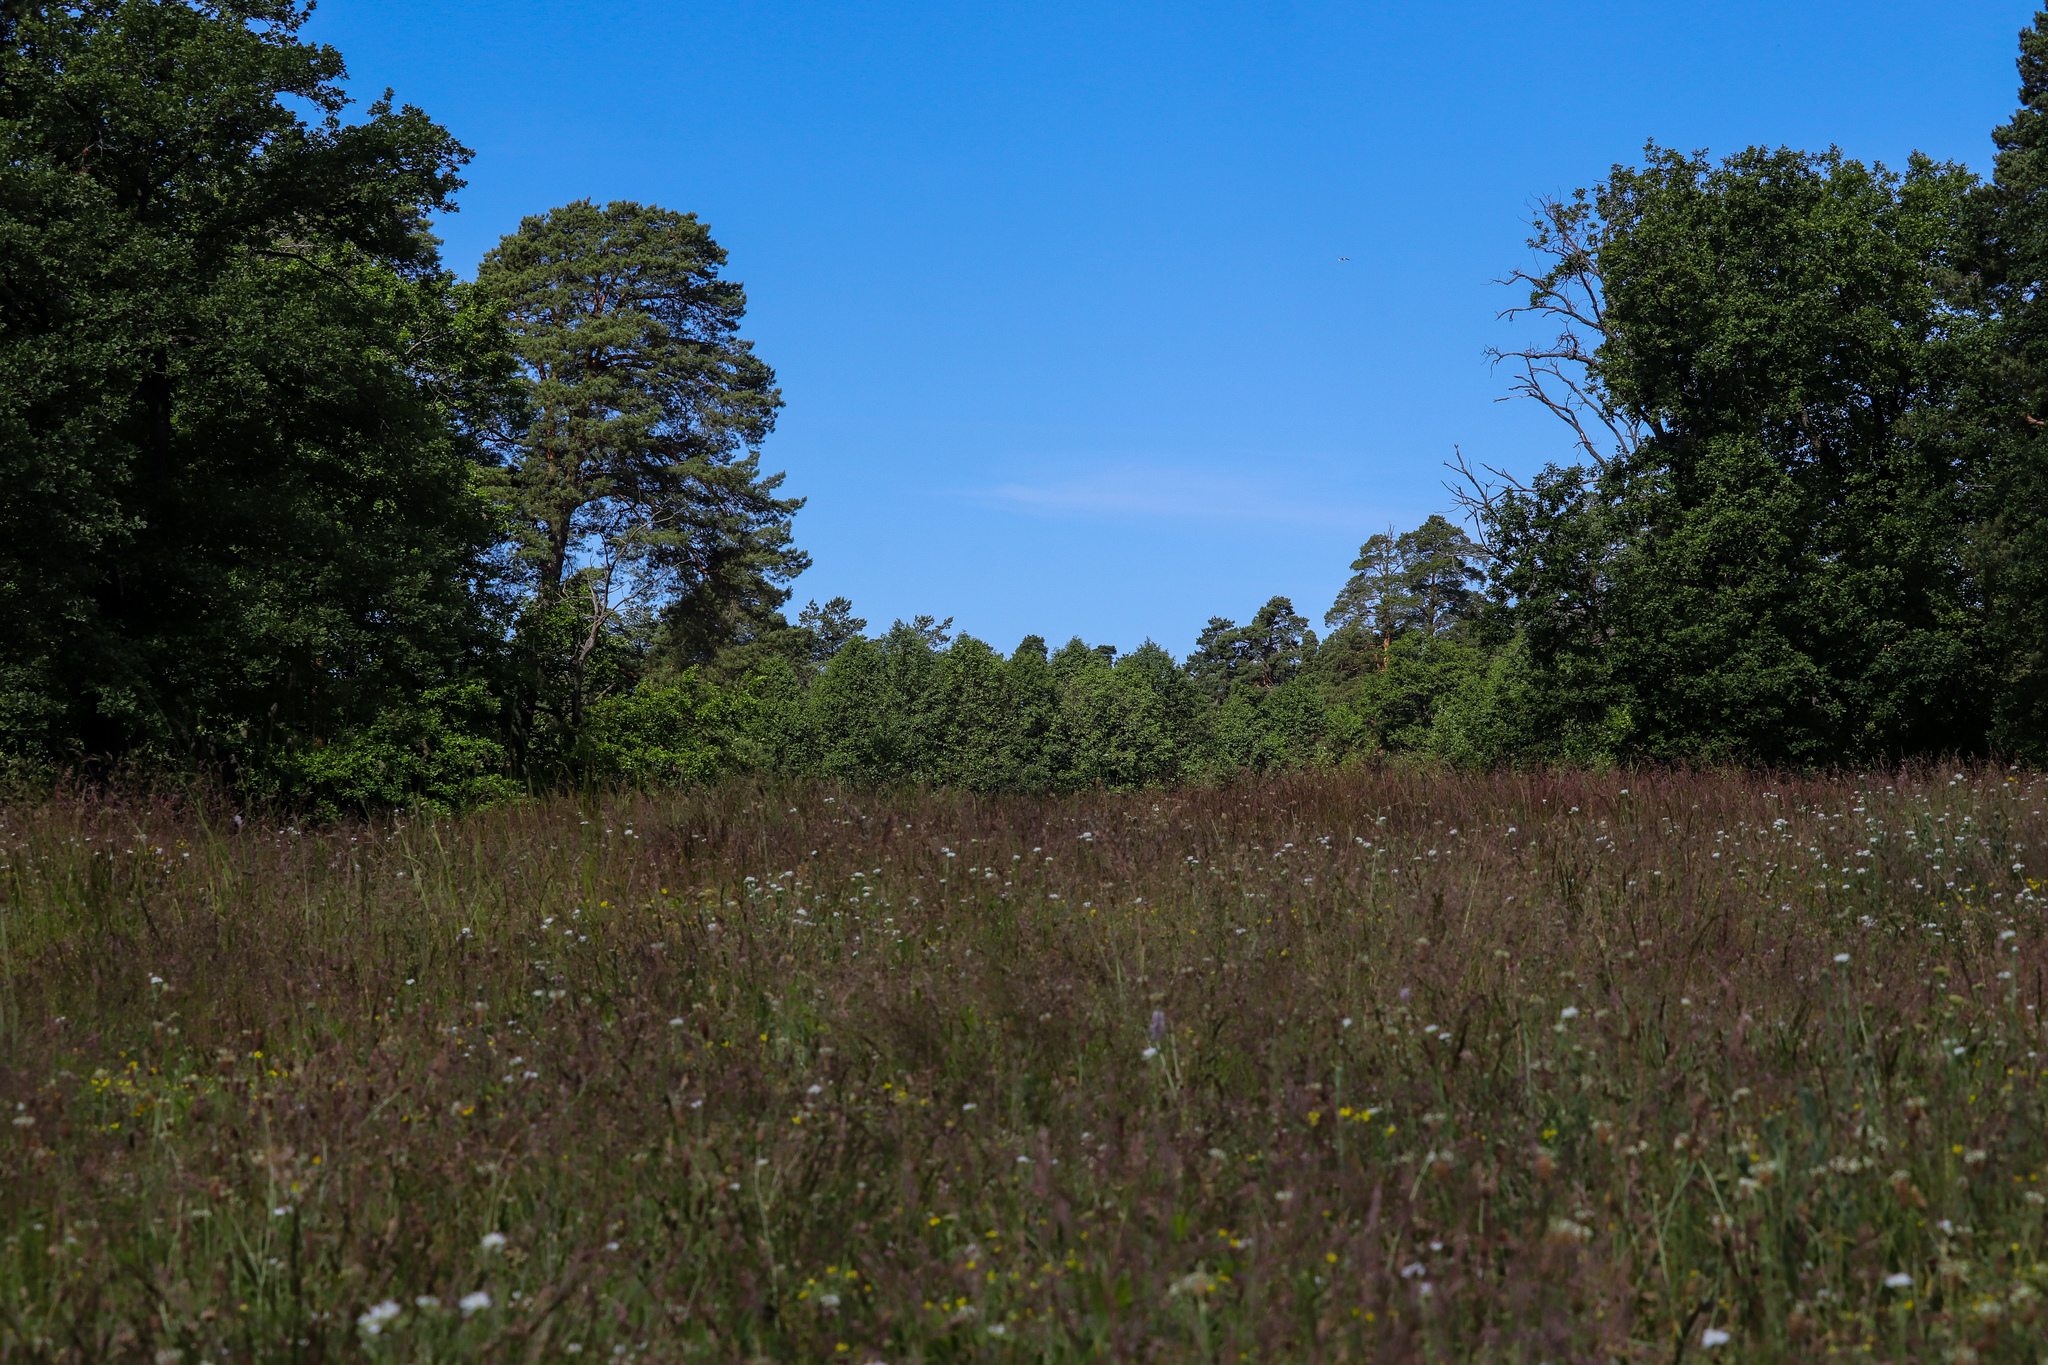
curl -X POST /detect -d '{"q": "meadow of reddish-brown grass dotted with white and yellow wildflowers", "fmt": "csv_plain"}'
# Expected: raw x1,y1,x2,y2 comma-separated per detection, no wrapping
0,769,2048,1365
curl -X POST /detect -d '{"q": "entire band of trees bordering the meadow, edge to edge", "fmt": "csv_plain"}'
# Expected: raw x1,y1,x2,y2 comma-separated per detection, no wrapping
12,0,2048,808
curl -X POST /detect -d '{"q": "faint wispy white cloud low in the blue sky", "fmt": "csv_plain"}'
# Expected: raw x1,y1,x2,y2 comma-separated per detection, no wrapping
967,465,1374,526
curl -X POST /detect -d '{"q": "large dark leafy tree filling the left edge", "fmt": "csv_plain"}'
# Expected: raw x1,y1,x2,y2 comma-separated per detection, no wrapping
0,0,504,763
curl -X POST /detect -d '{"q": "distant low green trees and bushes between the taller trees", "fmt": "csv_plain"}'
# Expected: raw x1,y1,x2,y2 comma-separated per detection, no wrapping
307,516,1491,806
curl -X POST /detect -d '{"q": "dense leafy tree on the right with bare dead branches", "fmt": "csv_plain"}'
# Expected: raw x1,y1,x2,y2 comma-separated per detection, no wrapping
1481,147,1985,763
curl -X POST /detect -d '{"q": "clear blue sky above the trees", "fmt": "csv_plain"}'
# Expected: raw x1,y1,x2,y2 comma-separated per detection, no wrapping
311,0,2034,655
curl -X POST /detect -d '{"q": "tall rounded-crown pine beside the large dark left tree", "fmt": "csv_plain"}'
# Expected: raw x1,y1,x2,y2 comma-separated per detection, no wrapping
477,201,809,731
